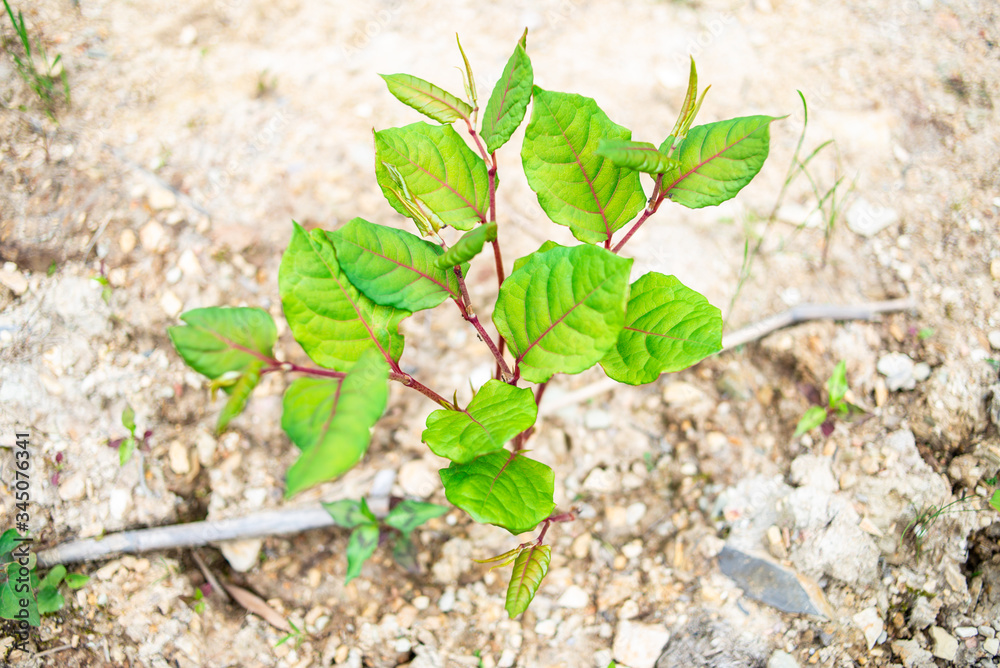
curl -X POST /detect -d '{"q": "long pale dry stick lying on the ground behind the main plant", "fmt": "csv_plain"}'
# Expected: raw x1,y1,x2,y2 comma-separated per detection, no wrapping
38,299,916,567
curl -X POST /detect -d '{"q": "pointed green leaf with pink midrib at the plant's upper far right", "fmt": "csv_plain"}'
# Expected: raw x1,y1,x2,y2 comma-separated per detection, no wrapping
660,116,777,209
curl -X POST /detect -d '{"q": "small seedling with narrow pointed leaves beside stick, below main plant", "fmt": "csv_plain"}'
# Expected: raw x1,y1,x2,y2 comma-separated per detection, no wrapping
323,499,448,584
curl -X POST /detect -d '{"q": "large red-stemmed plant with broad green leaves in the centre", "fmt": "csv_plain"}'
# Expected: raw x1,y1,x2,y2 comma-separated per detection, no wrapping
170,31,775,616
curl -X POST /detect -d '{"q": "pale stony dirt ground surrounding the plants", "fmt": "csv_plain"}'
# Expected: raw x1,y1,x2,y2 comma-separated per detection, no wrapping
0,0,1000,668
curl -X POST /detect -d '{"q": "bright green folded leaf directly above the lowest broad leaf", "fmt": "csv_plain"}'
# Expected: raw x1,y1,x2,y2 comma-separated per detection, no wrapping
421,380,538,464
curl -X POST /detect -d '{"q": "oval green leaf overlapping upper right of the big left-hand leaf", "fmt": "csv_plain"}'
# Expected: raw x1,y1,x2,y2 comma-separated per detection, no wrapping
330,218,461,311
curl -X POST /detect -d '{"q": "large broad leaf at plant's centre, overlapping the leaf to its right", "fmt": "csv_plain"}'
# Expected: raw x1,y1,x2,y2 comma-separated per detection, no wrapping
493,245,632,383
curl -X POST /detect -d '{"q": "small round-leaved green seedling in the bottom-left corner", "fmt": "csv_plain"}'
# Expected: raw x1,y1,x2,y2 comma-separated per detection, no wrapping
0,529,90,626
